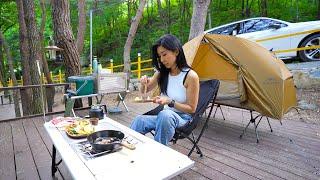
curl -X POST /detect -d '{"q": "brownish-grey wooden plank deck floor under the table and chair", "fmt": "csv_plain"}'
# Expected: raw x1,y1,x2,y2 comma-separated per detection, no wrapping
0,103,320,180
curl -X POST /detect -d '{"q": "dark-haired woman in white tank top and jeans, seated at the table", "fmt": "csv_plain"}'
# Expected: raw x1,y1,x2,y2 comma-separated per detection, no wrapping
131,35,199,145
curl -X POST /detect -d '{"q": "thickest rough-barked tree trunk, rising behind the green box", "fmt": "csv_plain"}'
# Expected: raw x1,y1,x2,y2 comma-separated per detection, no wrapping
52,0,81,78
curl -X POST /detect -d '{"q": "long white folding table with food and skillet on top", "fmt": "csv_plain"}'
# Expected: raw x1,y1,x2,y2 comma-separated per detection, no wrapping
44,118,194,180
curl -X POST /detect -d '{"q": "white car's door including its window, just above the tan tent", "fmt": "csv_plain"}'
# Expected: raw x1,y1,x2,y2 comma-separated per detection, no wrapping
237,19,291,57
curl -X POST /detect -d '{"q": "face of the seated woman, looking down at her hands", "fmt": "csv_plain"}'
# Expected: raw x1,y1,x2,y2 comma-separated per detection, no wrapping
157,46,178,69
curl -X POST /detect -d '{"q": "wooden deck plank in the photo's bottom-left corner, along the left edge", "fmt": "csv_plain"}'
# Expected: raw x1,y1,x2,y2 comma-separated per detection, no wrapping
0,123,16,179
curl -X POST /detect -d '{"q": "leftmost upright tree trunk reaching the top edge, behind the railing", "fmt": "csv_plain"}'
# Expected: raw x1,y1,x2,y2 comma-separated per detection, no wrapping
16,0,32,116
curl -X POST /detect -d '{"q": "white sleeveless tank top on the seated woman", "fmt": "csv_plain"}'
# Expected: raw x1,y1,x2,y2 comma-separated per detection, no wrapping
165,69,189,112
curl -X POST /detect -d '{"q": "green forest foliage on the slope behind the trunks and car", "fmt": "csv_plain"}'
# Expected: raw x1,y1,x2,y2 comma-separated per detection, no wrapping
0,0,319,76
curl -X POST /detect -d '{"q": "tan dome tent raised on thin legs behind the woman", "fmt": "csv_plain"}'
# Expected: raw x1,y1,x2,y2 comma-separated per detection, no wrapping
183,34,296,120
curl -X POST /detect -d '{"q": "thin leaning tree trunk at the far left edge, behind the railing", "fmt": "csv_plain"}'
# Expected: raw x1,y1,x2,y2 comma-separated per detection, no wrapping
0,31,21,117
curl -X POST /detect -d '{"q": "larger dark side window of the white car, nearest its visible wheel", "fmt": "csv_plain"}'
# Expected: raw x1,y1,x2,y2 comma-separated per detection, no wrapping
243,19,287,33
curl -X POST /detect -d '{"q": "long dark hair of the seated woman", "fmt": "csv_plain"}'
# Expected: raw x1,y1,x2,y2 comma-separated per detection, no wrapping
151,34,190,94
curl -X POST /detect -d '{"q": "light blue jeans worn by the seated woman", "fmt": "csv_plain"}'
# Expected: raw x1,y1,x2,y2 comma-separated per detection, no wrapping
130,109,192,145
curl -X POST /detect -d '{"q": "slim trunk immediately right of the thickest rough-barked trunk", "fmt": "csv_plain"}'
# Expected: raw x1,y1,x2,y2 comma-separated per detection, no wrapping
76,0,86,54
